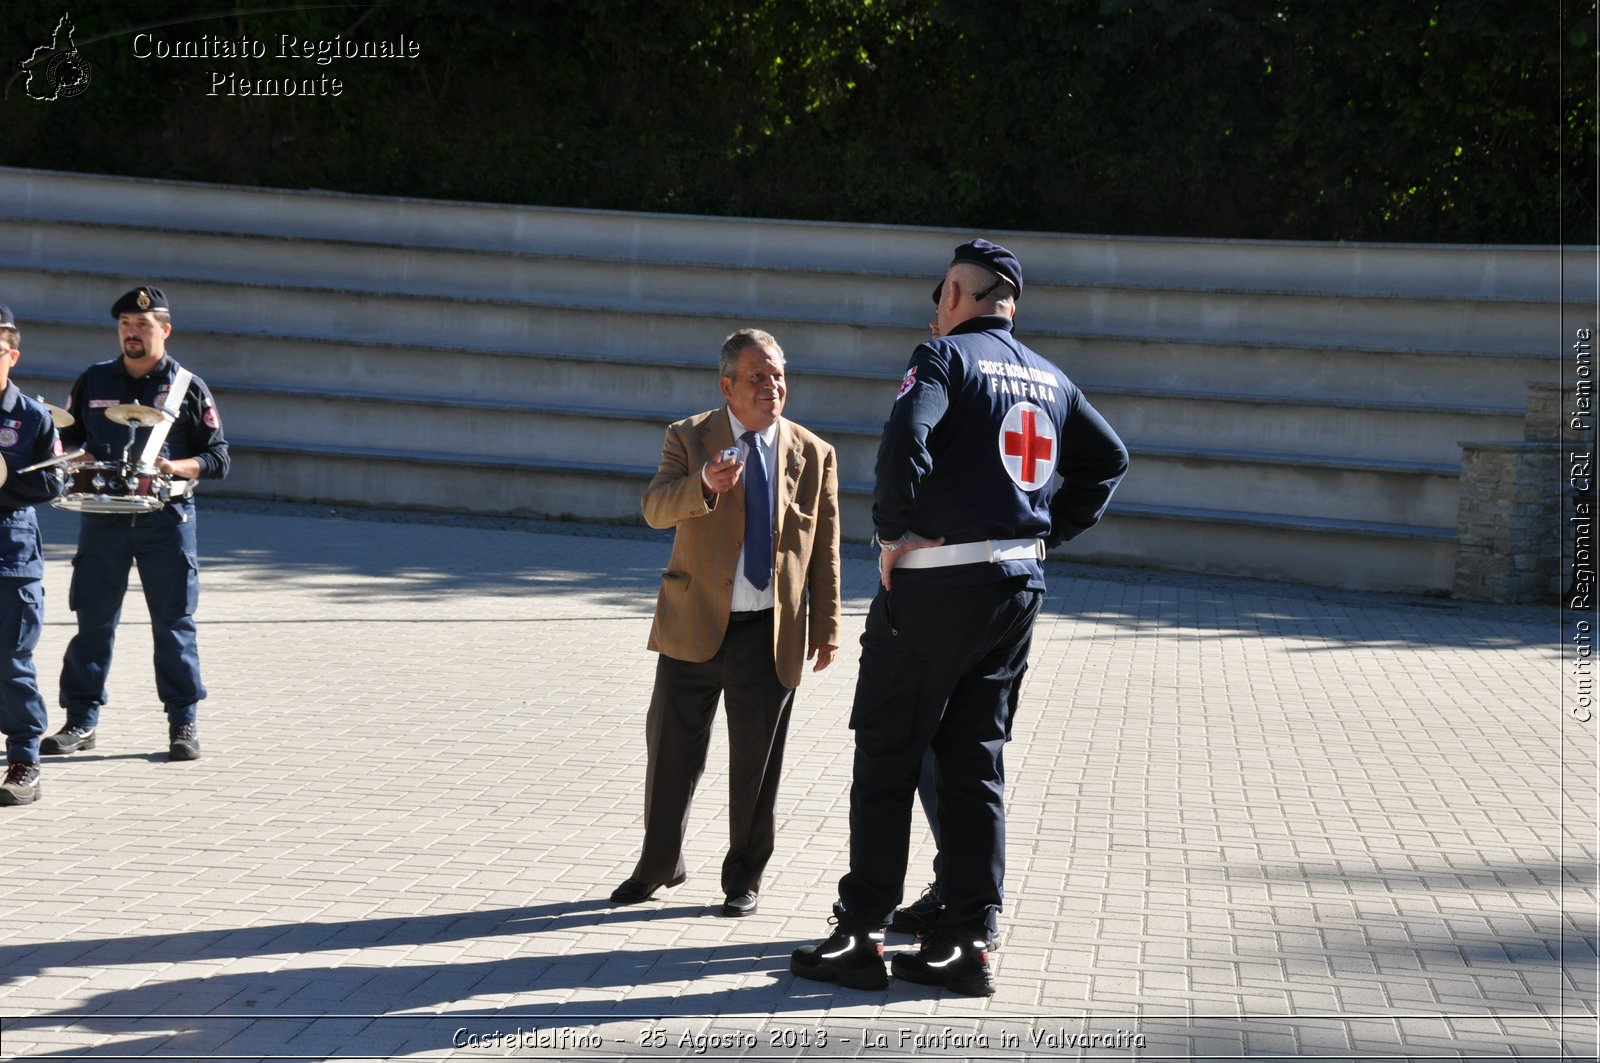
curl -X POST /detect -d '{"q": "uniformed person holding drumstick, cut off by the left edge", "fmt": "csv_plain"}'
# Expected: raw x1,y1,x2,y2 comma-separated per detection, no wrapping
0,306,61,805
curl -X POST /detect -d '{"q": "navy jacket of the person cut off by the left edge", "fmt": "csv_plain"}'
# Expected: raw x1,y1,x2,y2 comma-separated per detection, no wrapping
0,384,61,580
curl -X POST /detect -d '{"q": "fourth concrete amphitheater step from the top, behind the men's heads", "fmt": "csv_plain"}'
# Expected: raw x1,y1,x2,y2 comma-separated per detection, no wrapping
9,315,1548,463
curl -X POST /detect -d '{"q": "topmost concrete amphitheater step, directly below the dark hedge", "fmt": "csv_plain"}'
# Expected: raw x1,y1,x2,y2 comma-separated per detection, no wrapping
0,166,1592,303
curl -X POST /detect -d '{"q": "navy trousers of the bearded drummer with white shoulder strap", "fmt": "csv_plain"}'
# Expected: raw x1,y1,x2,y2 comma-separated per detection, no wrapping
61,501,205,727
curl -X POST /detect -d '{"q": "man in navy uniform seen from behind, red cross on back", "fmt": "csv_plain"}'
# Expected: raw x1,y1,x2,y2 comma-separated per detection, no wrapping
790,240,1128,996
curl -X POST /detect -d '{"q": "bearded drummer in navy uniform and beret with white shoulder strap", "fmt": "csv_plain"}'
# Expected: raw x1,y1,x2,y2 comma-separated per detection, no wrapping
40,285,229,760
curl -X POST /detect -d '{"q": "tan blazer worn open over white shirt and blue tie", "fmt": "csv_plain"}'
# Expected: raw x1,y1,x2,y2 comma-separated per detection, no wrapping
643,407,840,688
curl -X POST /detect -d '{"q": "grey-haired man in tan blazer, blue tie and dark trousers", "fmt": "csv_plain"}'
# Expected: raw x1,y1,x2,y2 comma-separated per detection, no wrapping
611,328,840,916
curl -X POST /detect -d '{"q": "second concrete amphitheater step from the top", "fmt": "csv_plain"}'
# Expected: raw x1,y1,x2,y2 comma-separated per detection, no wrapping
0,221,1550,352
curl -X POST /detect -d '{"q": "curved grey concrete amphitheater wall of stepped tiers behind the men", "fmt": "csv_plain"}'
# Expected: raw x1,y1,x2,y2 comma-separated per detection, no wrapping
0,168,1574,592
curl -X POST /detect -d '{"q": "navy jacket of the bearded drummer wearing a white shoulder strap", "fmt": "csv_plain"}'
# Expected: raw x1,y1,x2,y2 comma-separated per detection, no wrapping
61,355,229,480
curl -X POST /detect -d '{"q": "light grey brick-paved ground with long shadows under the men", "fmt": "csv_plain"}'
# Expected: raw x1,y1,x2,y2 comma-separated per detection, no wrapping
0,501,1597,1060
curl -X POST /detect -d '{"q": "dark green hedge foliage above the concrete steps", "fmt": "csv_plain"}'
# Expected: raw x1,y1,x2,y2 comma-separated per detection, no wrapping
3,0,1597,243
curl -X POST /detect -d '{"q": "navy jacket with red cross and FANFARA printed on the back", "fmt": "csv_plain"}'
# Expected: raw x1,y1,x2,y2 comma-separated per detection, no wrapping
872,315,1128,588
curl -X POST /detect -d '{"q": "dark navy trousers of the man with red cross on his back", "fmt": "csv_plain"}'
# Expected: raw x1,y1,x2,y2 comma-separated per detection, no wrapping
838,576,1043,930
